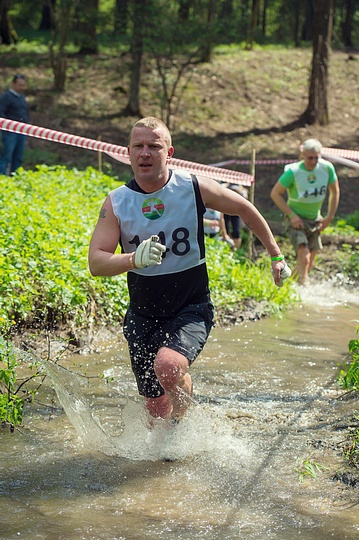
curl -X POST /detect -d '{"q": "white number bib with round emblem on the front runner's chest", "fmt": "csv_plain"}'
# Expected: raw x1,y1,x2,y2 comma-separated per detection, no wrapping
110,171,205,276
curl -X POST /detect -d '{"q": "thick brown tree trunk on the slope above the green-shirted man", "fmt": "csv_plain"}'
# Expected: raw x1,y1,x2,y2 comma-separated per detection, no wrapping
303,0,334,126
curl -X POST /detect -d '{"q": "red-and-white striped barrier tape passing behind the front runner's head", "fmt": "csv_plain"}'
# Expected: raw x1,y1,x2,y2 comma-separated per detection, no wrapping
0,118,254,186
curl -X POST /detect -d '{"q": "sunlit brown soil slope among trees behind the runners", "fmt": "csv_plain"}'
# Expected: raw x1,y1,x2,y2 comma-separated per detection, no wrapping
0,49,359,219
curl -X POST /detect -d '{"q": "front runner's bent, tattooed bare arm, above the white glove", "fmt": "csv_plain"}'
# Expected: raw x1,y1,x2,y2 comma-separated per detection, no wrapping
88,197,134,276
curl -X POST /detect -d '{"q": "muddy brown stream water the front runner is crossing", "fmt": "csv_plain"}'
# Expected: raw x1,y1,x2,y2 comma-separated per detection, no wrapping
0,284,359,540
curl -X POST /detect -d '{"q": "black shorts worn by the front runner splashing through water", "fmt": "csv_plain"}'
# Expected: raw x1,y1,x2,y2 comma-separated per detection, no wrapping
123,301,213,398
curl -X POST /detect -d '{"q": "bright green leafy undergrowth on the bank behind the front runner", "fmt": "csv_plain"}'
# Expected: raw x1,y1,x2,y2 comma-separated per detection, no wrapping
0,165,294,328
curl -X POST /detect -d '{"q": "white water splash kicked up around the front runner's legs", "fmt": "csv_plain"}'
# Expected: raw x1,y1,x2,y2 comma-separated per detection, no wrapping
44,362,249,461
